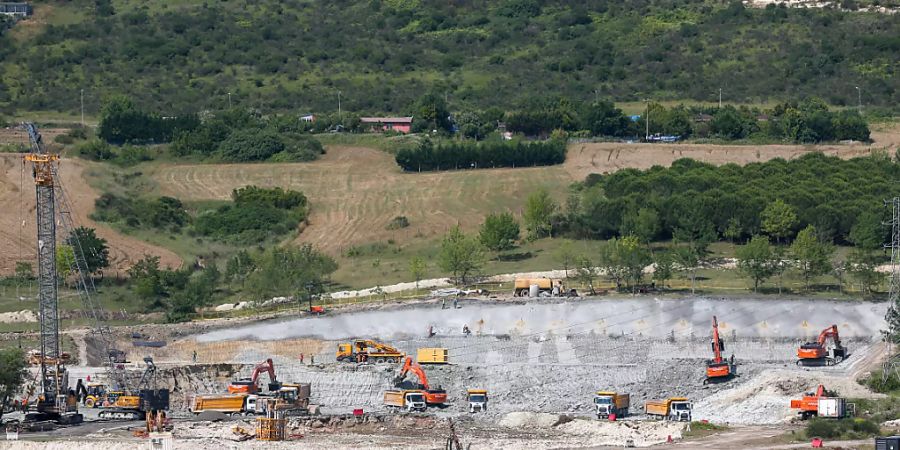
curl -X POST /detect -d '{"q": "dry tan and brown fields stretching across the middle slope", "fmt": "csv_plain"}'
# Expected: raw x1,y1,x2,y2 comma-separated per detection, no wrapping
0,123,900,273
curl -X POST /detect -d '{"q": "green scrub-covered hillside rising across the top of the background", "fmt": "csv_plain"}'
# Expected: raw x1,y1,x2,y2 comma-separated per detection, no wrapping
0,0,900,114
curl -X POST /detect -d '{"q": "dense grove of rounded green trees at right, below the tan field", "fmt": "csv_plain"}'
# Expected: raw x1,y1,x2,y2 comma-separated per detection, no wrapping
568,153,900,244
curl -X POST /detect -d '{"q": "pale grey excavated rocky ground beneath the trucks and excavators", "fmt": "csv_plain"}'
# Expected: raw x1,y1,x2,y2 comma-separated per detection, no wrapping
0,297,886,450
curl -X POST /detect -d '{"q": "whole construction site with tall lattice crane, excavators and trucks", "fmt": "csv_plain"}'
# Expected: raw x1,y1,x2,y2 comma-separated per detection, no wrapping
0,124,900,449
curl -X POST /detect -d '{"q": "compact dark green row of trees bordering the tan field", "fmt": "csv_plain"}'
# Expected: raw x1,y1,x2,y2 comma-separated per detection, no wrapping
396,139,566,172
